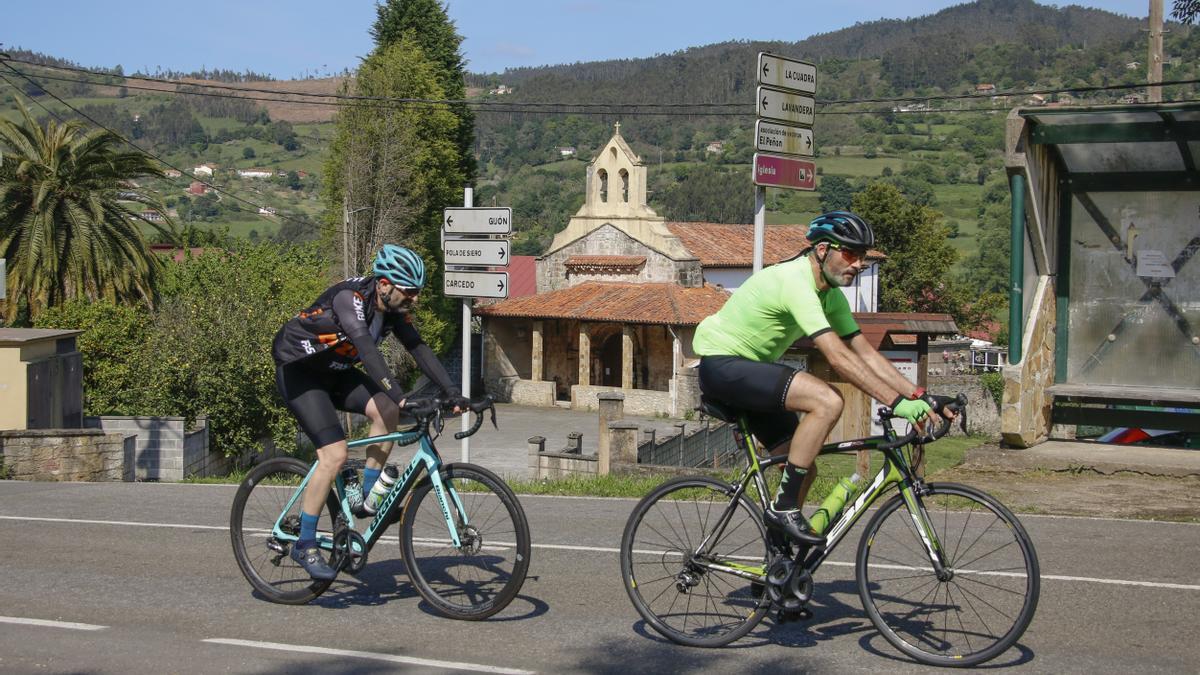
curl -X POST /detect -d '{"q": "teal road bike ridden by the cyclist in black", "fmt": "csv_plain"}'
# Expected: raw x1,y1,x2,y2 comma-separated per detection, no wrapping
229,398,529,620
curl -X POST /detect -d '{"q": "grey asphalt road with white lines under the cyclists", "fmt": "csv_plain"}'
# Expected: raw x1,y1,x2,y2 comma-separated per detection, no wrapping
0,482,1200,674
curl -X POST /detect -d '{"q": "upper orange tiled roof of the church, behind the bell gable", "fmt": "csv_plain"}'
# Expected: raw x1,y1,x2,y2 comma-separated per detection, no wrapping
667,222,887,267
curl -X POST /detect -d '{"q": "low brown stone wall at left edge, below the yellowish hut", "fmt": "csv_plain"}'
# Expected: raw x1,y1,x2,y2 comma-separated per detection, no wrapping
0,429,136,482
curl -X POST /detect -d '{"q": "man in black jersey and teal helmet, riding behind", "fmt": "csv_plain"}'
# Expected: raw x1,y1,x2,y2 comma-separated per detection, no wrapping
271,244,467,579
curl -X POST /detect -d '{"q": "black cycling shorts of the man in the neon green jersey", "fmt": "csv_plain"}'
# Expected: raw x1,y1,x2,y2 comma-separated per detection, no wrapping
700,357,800,450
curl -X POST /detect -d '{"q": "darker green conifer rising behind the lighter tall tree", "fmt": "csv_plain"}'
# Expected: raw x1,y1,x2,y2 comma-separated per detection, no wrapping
371,0,475,183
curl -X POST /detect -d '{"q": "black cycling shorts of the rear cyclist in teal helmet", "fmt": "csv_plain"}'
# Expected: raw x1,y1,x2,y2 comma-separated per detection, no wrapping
275,363,383,448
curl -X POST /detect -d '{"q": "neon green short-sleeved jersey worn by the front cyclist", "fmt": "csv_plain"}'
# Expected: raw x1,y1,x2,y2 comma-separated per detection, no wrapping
692,256,859,362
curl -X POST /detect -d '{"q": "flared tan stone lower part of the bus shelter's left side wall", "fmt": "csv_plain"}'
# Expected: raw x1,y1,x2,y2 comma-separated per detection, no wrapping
1000,276,1056,448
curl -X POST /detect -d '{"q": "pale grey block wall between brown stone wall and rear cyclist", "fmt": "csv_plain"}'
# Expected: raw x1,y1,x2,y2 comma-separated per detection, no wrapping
84,416,213,480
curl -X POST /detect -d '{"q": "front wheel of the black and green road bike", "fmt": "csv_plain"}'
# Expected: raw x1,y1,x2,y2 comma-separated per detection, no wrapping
857,483,1042,667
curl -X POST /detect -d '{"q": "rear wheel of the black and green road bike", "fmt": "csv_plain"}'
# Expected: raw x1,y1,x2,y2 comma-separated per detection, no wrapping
620,476,770,647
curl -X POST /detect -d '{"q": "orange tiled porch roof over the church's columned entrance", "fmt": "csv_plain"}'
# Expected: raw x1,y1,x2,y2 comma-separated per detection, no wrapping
476,281,730,325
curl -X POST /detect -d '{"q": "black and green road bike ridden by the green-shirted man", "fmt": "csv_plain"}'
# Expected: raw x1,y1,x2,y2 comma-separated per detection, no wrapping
620,394,1040,667
